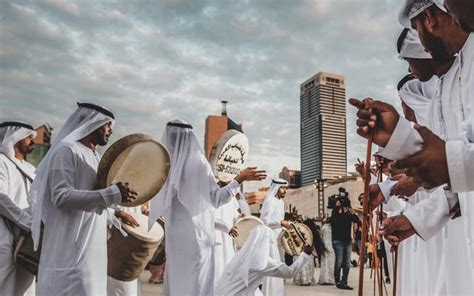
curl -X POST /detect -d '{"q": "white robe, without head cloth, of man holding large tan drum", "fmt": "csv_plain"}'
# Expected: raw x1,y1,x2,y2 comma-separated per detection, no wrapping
37,142,121,296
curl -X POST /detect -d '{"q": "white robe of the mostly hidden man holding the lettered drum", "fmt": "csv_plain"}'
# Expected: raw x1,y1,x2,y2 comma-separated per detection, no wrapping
214,198,239,286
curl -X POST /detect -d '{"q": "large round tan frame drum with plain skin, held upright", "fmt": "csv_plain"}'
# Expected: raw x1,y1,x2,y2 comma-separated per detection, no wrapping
97,134,170,207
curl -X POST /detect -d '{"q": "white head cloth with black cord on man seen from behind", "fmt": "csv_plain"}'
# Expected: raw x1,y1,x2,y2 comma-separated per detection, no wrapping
148,120,217,227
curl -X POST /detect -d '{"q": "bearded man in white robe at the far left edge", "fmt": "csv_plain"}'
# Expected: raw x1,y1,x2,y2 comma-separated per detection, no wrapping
0,121,36,296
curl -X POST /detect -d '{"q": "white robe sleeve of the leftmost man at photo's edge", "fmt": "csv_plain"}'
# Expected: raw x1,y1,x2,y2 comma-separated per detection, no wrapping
0,161,32,230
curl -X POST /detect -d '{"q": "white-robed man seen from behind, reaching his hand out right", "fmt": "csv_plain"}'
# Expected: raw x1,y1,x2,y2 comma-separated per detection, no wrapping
149,120,266,296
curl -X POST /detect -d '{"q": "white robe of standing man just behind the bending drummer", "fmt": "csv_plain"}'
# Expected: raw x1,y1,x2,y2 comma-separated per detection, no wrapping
260,197,285,296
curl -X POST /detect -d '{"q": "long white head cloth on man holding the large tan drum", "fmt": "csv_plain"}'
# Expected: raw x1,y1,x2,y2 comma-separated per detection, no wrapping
30,103,115,249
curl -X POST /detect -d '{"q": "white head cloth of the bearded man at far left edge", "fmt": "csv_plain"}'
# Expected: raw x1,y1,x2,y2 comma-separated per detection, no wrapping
0,125,36,179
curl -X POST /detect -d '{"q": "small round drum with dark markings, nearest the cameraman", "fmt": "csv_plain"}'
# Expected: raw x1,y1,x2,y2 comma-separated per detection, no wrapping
278,223,313,256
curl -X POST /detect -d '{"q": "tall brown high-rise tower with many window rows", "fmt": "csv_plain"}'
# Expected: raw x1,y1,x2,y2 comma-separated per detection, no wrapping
300,72,347,186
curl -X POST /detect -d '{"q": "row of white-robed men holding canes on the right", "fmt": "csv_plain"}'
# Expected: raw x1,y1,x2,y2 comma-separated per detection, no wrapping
350,0,474,295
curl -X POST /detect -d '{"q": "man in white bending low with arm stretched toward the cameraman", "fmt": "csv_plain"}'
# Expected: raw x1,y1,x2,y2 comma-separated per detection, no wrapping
215,225,312,296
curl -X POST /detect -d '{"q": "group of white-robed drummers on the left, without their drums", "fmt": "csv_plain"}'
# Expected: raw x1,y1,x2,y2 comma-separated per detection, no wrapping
0,103,312,295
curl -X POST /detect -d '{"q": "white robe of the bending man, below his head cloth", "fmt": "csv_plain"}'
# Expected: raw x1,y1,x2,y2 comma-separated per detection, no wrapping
215,252,311,296
